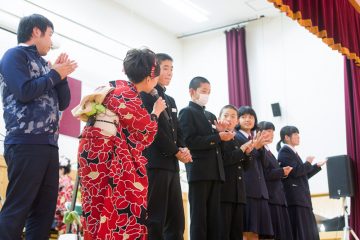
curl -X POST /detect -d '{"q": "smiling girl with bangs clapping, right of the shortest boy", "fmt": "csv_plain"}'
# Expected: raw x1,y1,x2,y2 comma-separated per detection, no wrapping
236,106,273,240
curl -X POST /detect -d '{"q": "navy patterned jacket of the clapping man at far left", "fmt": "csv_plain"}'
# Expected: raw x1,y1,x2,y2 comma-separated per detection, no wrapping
0,45,70,146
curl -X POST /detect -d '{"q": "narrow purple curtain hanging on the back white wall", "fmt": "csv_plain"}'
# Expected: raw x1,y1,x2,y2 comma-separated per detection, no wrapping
225,28,251,107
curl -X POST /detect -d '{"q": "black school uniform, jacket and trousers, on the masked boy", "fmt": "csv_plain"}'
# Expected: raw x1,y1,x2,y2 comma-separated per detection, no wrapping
179,102,225,240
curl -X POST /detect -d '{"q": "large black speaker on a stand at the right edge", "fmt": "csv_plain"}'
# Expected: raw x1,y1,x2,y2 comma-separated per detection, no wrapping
326,155,354,199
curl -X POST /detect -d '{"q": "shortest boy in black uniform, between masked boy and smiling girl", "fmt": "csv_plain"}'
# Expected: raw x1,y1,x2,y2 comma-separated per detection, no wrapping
219,105,252,240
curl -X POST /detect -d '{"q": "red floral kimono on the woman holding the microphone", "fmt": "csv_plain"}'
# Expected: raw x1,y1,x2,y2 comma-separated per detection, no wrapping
78,80,157,240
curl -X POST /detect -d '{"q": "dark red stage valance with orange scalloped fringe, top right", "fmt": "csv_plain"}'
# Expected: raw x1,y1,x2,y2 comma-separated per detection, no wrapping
268,0,360,66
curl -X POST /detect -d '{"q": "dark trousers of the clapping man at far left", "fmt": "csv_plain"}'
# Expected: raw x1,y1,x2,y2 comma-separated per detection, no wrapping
0,144,59,240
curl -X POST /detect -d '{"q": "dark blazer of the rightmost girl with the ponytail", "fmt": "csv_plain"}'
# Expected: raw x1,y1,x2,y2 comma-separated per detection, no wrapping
278,145,321,208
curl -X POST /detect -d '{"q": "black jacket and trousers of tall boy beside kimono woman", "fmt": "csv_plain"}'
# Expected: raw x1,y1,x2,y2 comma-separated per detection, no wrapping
141,85,185,240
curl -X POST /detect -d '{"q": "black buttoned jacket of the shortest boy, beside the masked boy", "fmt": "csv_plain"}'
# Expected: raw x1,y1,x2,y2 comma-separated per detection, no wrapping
221,139,251,204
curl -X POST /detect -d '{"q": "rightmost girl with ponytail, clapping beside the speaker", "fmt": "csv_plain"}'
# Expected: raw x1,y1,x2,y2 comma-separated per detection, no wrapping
276,126,326,240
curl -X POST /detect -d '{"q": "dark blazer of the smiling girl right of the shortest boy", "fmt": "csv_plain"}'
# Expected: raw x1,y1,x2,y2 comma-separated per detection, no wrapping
235,131,269,199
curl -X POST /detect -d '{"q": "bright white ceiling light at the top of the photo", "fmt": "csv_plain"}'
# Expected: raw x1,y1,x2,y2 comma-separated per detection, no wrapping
162,0,209,22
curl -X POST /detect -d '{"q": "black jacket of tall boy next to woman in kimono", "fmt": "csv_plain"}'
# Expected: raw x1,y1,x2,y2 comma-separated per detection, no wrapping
141,85,185,171
